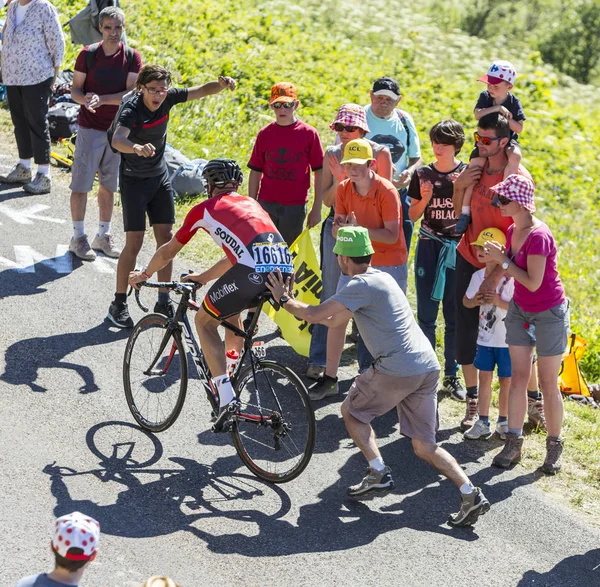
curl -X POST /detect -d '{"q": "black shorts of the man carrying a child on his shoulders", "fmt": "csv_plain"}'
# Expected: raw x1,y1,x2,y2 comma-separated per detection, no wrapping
456,253,479,365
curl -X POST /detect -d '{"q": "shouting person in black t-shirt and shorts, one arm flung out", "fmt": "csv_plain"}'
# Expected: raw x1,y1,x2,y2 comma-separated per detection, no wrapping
107,65,236,328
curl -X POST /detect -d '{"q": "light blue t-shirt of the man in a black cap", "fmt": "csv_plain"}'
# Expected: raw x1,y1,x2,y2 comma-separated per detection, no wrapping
365,105,421,179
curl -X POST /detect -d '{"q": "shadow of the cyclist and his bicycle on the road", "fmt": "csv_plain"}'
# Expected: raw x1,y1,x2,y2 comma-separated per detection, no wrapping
43,421,291,538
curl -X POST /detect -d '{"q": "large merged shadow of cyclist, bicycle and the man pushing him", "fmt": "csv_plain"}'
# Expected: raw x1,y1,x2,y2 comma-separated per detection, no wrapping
44,422,535,557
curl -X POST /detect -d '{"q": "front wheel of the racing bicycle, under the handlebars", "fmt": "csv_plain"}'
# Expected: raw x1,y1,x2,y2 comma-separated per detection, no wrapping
123,314,188,432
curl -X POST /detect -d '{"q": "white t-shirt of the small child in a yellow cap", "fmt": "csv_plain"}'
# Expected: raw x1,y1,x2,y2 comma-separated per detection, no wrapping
466,269,515,348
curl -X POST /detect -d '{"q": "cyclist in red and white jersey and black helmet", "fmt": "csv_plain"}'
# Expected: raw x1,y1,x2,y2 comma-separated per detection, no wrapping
129,159,293,408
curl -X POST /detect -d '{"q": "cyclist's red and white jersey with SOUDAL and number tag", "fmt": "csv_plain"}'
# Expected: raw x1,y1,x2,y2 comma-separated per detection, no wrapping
175,192,293,273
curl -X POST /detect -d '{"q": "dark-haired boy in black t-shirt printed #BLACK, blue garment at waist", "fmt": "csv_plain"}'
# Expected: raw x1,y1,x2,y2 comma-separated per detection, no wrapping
408,120,466,401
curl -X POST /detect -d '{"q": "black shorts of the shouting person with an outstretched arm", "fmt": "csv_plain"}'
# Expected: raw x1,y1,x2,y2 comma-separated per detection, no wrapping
119,171,175,232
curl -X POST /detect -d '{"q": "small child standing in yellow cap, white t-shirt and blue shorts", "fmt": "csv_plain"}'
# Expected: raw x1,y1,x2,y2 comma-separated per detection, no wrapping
461,228,514,440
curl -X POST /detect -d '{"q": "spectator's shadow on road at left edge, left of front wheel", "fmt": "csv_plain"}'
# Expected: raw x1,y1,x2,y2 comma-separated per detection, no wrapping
0,324,129,393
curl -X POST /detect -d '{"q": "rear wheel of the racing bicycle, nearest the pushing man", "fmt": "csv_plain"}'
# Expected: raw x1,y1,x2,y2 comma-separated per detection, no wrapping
231,361,316,483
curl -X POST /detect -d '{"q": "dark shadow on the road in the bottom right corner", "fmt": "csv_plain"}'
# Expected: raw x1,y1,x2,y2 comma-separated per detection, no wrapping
517,548,600,587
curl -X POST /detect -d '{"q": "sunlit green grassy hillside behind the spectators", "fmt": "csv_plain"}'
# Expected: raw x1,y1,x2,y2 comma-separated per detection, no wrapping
2,0,600,524
